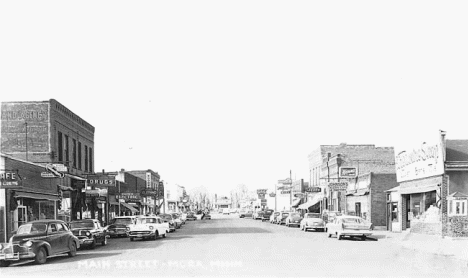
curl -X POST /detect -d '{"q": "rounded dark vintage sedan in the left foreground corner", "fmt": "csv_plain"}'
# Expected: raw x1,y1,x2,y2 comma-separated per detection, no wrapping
0,219,80,267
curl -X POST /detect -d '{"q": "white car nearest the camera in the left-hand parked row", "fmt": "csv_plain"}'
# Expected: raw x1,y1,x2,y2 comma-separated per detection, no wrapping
127,216,169,241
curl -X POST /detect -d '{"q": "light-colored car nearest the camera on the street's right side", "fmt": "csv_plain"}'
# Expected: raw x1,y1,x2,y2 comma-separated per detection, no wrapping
325,215,372,240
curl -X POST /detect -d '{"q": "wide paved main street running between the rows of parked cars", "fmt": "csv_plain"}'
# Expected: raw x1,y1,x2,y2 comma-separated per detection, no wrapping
0,214,468,277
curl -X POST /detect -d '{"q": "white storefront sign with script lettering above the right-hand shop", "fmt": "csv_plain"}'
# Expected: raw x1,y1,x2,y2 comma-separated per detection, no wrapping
395,136,444,182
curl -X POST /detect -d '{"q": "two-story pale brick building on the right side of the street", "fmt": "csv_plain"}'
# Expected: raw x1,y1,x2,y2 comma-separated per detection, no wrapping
307,143,395,212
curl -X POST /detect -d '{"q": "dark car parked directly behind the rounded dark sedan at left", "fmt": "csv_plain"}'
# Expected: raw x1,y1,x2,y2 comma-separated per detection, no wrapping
69,219,108,249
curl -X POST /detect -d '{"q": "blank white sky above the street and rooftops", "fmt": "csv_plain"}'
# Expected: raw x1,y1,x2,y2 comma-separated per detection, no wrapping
0,0,468,193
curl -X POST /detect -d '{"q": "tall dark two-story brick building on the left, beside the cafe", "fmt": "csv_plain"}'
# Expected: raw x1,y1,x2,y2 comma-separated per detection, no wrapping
0,99,95,238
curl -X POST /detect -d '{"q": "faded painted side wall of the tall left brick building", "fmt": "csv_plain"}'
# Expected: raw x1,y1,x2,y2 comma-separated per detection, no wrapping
1,103,50,153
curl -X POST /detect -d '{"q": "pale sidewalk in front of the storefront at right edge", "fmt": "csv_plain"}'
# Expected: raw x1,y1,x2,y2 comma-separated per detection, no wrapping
373,231,468,264
